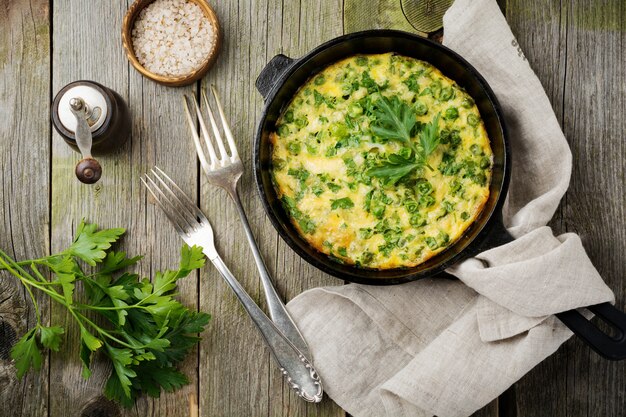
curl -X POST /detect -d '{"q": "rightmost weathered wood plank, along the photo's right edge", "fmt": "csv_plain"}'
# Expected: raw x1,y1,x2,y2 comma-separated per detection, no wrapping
563,0,626,417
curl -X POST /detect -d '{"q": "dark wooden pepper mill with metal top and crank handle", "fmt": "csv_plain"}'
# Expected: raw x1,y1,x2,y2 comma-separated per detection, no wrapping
51,81,131,184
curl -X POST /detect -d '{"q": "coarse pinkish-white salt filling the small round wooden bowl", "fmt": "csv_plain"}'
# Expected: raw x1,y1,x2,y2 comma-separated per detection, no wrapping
131,0,216,77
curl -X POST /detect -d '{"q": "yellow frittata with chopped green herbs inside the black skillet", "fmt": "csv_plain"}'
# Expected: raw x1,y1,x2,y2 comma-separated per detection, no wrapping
270,53,493,269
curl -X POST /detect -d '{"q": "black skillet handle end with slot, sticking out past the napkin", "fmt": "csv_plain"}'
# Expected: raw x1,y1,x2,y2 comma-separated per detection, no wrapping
556,303,626,361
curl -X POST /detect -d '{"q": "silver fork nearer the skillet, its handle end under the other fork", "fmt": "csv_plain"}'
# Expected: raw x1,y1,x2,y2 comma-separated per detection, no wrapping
184,86,311,358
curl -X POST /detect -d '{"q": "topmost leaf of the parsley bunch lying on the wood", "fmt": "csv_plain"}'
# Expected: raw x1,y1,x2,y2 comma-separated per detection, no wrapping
64,220,126,266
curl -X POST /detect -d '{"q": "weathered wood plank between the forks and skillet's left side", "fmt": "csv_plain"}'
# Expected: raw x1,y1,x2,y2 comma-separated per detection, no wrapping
200,0,343,417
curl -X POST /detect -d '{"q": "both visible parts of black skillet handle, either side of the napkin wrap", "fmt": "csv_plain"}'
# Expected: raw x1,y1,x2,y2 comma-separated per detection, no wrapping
480,213,626,361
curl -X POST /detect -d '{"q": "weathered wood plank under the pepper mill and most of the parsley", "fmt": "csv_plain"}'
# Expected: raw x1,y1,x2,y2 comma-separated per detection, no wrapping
50,0,197,416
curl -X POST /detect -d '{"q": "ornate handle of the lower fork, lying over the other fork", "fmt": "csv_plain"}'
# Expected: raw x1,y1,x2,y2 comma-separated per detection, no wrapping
210,252,323,403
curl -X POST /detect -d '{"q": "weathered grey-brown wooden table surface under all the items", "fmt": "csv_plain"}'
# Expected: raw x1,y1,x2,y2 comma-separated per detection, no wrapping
0,0,626,417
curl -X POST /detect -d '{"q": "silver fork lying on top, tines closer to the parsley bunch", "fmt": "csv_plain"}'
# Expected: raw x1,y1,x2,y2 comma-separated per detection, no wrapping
141,167,323,402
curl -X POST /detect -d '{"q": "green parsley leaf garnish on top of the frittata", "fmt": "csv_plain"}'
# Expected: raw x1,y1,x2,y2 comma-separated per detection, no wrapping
367,96,441,185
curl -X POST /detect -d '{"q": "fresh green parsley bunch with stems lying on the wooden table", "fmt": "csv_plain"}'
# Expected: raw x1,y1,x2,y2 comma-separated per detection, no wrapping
0,222,210,407
